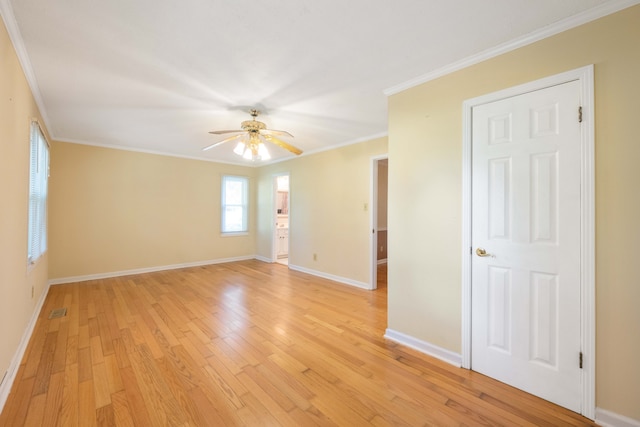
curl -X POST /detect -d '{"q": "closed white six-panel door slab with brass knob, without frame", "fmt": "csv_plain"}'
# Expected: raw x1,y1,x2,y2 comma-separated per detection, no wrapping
471,81,581,412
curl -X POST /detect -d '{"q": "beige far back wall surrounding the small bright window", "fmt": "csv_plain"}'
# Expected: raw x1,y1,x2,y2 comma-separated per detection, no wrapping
49,142,256,279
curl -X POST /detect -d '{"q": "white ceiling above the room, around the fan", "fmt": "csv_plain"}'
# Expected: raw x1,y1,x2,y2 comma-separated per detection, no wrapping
0,0,638,164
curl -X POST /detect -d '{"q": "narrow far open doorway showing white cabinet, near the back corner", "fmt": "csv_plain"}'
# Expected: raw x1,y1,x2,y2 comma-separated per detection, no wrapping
273,173,290,265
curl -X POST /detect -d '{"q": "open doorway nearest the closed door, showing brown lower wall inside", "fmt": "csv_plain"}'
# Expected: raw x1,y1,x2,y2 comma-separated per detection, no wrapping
370,154,389,289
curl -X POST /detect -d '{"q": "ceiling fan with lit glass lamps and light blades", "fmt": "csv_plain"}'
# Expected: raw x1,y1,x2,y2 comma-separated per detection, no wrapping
202,109,302,160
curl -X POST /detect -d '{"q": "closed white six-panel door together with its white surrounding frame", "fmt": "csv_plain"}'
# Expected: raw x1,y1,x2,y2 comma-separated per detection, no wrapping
462,66,595,419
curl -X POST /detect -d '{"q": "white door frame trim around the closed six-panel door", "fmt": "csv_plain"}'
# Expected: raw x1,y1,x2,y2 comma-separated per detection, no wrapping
462,65,596,420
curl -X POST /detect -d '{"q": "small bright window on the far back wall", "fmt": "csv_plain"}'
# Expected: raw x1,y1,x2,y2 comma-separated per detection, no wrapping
222,175,249,233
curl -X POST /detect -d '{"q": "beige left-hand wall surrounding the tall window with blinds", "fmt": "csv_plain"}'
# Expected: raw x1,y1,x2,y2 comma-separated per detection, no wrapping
0,20,47,386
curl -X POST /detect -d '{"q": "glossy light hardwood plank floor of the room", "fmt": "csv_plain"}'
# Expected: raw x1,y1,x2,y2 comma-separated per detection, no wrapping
0,261,594,427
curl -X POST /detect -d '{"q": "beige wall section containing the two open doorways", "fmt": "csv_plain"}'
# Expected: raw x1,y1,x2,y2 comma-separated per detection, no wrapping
258,138,387,283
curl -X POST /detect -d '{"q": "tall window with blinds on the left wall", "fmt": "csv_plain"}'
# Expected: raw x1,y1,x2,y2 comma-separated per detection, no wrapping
27,120,49,264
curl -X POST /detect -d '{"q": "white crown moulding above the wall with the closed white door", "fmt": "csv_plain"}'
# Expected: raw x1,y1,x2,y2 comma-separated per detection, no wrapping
383,0,640,96
